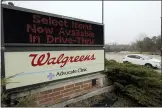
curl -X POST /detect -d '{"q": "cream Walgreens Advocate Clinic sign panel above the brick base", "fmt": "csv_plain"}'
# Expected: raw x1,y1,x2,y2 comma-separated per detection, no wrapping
5,50,104,89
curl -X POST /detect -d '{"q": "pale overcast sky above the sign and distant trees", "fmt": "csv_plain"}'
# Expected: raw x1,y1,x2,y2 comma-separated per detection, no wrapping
2,1,161,44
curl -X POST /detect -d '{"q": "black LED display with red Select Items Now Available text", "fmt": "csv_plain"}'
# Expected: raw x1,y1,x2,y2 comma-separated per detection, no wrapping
2,8,104,45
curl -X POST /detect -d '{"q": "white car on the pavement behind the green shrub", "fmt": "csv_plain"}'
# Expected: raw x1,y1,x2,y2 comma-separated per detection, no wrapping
123,54,161,68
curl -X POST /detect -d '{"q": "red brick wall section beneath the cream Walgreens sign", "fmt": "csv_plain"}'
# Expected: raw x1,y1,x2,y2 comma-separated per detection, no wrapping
33,79,100,106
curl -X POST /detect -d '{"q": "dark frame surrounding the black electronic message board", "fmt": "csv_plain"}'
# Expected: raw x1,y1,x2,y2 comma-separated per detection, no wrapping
2,5,104,47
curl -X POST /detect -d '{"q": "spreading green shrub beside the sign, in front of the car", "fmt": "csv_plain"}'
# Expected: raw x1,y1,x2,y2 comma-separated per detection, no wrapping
105,60,162,107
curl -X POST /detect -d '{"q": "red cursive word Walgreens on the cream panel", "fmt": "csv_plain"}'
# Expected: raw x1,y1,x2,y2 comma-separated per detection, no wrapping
29,53,96,68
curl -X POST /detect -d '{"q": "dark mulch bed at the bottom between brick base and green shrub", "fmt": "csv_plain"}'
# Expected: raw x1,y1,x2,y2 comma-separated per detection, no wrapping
65,92,139,107
